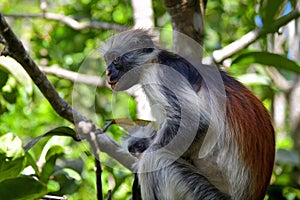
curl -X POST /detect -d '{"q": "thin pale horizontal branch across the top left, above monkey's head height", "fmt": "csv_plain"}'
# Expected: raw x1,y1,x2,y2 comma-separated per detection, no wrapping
3,12,128,31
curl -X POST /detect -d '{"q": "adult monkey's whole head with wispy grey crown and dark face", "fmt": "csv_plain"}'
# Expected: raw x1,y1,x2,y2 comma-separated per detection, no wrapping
102,29,158,90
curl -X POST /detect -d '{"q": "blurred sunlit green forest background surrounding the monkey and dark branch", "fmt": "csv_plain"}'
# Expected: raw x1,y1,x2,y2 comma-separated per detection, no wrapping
0,0,300,200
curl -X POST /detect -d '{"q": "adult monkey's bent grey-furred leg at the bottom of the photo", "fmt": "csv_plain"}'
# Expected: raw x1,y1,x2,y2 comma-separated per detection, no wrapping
139,151,230,200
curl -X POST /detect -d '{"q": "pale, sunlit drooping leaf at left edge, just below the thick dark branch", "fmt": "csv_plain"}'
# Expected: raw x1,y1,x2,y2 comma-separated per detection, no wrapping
0,56,33,93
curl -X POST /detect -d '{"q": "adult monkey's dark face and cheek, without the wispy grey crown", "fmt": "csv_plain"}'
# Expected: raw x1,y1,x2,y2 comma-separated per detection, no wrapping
104,48,155,91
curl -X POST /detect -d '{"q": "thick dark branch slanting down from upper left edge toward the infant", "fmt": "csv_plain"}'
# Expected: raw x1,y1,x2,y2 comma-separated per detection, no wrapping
0,13,136,169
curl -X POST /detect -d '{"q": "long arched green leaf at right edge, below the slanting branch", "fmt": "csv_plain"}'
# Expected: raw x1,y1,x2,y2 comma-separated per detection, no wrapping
232,51,300,73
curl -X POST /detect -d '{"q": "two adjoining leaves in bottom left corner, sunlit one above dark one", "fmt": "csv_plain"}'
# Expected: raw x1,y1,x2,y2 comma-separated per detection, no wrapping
0,133,47,199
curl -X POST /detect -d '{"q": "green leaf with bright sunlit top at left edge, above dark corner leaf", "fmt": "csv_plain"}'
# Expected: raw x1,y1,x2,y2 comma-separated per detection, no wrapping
0,133,26,181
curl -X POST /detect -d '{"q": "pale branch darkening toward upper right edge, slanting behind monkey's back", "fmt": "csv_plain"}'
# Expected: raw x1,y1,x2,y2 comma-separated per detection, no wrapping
203,10,300,64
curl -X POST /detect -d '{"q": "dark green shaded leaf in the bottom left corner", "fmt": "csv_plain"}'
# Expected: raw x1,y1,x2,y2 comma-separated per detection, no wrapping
0,176,48,200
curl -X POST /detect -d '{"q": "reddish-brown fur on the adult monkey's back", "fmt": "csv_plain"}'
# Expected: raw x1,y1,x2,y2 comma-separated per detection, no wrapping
222,74,275,200
